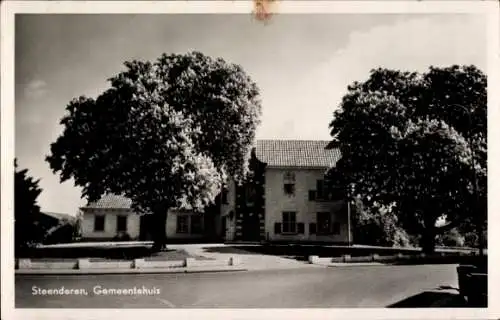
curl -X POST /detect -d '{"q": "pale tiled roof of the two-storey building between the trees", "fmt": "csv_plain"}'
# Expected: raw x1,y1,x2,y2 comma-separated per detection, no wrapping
255,140,340,168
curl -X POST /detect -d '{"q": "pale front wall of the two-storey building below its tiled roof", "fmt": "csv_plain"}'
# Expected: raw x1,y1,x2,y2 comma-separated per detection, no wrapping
265,168,348,242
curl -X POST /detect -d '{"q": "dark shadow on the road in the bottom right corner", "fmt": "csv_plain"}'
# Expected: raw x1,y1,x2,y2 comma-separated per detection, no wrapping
388,291,468,308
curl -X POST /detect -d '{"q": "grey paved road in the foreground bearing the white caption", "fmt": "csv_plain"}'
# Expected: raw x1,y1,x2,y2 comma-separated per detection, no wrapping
15,265,464,308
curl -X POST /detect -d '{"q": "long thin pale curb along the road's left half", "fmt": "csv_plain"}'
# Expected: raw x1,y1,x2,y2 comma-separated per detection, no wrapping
15,267,248,275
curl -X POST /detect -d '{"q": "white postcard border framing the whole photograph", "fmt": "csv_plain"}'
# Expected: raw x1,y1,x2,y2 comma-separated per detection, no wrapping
1,0,500,320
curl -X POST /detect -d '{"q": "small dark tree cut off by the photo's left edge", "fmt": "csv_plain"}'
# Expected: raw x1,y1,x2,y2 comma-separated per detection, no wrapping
14,160,44,253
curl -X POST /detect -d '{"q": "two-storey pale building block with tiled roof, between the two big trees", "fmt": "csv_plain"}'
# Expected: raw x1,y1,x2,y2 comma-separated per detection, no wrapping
222,140,351,243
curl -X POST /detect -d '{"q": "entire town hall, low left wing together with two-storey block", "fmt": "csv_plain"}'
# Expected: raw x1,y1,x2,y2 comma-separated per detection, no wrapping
82,140,351,243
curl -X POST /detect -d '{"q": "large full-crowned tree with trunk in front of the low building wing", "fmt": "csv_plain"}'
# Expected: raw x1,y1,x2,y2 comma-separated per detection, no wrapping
47,52,261,249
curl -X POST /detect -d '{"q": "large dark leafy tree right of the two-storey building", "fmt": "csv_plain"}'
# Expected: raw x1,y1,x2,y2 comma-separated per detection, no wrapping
328,66,487,252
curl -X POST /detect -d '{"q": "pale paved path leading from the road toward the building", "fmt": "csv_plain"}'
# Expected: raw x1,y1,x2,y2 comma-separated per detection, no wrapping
168,244,322,270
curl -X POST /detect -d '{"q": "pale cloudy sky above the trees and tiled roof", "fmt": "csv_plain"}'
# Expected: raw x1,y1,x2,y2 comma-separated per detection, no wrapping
15,14,487,214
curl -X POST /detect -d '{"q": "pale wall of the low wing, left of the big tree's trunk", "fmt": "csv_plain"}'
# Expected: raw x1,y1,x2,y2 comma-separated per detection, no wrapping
82,209,140,239
